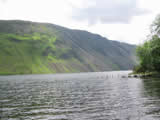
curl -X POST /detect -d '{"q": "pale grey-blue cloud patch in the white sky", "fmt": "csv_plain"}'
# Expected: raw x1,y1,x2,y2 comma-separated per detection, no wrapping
73,0,148,24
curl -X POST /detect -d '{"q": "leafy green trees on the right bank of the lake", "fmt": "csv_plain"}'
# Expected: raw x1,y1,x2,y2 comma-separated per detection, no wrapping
134,15,160,73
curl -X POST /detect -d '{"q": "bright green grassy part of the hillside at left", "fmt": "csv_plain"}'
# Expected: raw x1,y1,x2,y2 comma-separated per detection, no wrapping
0,33,85,74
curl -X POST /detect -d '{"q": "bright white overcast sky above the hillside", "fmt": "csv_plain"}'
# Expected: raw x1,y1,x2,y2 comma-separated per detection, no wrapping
0,0,160,44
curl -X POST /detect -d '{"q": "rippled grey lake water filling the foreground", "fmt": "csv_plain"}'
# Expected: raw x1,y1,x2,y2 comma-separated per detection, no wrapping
0,71,160,120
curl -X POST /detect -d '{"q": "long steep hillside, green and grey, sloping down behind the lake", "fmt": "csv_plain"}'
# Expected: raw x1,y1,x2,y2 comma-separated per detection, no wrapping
0,21,136,74
